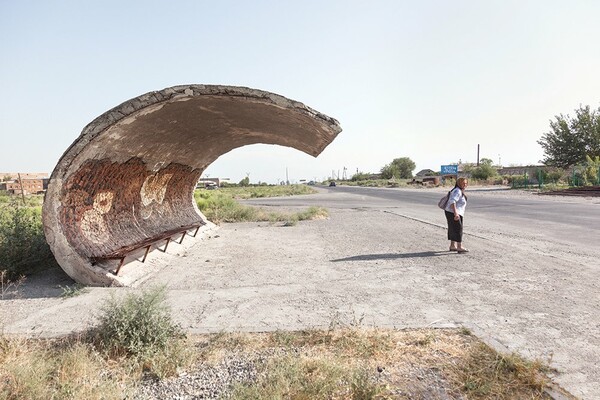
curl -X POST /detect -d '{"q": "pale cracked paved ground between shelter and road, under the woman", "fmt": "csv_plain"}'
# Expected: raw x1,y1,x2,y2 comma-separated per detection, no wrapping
0,191,600,399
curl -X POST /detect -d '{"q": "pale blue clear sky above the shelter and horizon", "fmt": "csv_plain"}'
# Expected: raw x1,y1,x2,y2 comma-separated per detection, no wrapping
0,0,600,182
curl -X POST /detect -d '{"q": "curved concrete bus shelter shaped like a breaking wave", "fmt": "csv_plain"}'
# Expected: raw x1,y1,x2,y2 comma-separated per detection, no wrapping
43,85,341,285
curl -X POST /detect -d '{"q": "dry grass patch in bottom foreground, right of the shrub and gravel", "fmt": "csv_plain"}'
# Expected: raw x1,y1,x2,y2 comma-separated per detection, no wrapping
193,327,549,399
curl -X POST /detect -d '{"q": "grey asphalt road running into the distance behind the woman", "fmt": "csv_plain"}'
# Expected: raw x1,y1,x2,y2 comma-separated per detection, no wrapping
248,186,600,248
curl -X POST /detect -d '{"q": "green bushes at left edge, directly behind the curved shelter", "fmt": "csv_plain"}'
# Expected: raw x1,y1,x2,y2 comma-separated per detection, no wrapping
0,197,58,280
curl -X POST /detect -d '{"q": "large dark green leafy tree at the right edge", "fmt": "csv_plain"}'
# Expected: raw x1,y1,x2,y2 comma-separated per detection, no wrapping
538,106,600,168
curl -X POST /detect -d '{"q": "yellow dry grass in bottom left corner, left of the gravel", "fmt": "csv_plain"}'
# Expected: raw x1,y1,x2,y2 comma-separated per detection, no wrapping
0,337,196,400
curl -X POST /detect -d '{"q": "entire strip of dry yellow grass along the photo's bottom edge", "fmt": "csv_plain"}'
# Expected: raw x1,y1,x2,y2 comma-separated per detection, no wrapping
0,327,564,400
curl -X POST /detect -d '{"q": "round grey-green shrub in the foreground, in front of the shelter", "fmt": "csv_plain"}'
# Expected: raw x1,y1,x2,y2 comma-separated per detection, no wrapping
96,286,183,358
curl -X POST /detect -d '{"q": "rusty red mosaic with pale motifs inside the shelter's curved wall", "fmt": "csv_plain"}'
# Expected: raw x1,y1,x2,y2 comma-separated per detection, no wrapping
59,158,203,257
